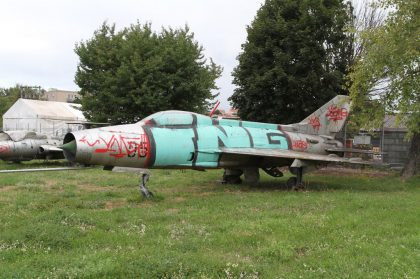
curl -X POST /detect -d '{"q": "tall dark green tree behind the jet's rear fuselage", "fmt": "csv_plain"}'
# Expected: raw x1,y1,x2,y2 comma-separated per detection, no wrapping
229,0,352,123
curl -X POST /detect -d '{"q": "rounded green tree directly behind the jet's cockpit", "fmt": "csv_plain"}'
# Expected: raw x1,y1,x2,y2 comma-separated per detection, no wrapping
75,23,221,124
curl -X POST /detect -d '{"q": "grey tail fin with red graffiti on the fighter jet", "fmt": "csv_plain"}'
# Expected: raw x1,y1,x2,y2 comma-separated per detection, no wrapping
298,95,351,137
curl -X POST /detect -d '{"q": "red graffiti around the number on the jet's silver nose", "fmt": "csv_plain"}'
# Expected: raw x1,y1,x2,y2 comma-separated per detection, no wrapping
79,135,149,159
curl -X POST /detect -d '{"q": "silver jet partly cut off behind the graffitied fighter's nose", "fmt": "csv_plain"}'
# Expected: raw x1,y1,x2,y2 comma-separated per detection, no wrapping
0,131,64,162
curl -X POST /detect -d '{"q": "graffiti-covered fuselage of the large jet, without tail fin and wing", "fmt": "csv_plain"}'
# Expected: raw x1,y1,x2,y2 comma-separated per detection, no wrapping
64,111,342,169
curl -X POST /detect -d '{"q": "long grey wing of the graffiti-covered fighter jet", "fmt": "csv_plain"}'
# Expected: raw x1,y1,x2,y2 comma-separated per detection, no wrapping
221,148,373,165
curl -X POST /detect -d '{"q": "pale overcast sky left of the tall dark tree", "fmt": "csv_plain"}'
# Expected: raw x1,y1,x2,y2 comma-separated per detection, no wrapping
0,0,264,108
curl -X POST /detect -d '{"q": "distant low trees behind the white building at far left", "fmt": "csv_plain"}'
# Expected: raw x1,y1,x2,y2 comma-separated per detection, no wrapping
0,84,45,128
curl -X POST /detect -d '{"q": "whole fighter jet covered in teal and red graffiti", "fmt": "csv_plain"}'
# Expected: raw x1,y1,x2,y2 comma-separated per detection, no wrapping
62,95,370,196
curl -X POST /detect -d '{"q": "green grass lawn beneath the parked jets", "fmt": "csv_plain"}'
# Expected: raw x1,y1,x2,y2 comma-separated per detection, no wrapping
0,162,420,278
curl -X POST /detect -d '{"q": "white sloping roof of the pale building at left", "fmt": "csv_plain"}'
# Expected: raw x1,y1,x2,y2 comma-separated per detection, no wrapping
5,99,86,120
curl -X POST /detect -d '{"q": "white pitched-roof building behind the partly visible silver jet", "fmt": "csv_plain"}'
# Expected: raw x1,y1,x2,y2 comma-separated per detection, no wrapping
3,99,86,136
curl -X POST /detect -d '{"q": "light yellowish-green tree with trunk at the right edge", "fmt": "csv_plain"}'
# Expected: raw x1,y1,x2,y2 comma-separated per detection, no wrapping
350,0,420,177
